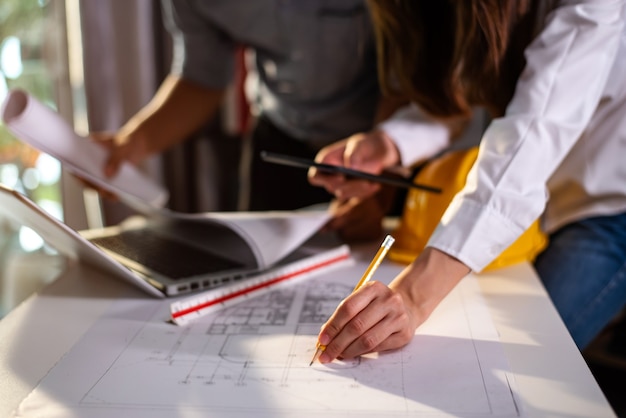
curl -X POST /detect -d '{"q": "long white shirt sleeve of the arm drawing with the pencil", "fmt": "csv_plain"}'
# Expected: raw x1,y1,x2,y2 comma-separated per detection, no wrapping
428,0,625,271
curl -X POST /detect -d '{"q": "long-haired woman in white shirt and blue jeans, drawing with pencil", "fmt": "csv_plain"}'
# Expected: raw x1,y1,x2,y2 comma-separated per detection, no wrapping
309,0,626,363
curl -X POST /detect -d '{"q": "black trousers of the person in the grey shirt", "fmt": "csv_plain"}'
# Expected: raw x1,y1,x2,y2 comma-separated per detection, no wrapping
248,117,332,211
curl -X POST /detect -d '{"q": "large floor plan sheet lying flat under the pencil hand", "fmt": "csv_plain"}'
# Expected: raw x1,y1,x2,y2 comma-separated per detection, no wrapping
16,262,523,418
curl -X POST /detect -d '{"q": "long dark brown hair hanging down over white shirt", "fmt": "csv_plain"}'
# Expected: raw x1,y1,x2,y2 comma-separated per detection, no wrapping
368,0,536,118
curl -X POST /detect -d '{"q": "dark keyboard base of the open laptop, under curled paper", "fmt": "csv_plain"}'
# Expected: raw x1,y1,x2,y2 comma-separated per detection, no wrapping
79,216,262,296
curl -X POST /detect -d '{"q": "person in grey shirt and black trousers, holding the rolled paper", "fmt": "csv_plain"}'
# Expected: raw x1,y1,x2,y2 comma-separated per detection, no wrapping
92,0,404,222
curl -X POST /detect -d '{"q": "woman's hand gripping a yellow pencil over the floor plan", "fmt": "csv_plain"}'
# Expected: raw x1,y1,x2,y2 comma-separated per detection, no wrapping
311,240,469,364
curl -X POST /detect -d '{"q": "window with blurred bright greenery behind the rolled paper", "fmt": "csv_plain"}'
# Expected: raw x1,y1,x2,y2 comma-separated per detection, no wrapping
0,0,84,317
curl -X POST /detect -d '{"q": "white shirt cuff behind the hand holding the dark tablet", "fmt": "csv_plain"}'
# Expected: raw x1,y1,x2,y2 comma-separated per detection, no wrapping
378,104,451,166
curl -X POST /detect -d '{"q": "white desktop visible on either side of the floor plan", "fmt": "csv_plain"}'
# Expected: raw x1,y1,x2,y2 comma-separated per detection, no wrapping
0,242,615,418
